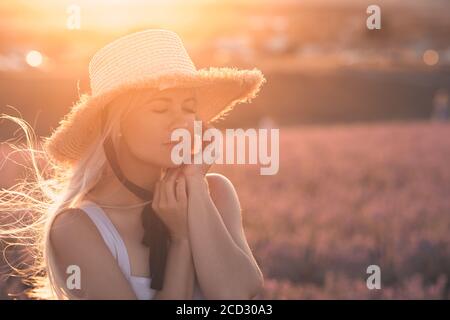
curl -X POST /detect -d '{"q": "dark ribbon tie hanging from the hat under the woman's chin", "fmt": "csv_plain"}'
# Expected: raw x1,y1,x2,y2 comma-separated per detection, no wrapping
102,104,170,290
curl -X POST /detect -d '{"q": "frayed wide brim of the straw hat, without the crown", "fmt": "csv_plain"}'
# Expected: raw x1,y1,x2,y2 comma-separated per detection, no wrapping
43,67,266,164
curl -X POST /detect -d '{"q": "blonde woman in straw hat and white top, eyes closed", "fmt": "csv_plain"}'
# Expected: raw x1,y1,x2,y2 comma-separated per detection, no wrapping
0,29,265,299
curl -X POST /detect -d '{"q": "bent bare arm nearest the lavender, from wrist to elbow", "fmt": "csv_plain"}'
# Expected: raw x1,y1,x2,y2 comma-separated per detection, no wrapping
187,175,263,299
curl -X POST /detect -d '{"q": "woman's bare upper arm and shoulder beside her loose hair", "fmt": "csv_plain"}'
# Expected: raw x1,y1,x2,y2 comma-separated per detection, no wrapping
50,209,136,300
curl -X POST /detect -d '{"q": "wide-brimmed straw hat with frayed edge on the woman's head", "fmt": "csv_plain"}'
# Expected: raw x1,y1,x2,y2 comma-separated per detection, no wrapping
43,29,266,164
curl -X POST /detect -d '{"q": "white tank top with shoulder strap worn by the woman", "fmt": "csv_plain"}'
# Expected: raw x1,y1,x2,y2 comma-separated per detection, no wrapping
80,200,204,300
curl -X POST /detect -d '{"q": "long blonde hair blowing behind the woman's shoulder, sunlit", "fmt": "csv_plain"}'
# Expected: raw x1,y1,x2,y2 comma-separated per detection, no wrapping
0,92,144,299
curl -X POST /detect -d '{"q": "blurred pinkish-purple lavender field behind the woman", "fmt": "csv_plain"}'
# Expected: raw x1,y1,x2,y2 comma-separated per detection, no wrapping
0,122,450,299
